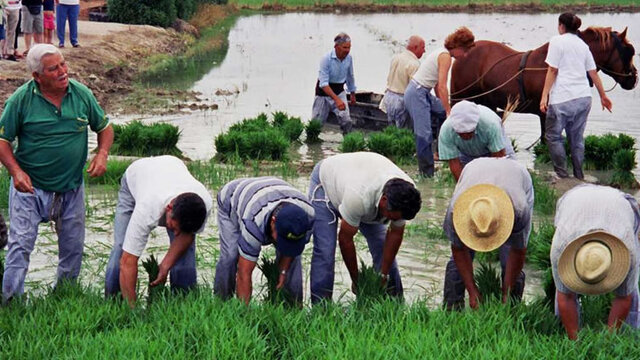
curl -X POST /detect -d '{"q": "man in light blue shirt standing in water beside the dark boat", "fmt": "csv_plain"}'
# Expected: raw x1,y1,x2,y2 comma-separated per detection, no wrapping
311,33,356,134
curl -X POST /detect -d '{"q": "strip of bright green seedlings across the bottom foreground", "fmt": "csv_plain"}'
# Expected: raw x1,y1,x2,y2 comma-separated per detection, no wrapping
0,288,640,359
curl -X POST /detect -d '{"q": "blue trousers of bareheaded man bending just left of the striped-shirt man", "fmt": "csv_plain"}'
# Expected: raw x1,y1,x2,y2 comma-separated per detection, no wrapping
104,176,197,296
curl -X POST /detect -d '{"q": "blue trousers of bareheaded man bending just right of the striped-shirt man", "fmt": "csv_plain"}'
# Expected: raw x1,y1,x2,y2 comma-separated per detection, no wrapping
309,162,403,304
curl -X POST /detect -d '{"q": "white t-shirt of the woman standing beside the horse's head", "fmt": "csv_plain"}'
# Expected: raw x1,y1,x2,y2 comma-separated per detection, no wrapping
545,33,596,104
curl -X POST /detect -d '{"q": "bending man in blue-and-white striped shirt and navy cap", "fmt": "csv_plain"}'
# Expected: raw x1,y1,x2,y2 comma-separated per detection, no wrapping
214,177,314,304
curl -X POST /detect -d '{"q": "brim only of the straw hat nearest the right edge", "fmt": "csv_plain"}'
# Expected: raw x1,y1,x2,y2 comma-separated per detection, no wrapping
558,231,631,295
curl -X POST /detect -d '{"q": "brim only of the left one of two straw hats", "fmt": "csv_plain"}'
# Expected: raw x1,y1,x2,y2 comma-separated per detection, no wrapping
453,184,515,252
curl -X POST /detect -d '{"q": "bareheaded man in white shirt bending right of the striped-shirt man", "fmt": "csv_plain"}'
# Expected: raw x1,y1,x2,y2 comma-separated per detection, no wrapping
309,152,421,304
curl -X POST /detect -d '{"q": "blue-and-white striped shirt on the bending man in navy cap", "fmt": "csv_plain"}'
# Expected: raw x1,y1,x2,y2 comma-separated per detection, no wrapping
218,176,315,261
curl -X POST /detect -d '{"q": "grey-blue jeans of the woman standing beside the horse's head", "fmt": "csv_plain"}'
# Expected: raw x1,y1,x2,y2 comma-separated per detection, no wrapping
544,97,591,179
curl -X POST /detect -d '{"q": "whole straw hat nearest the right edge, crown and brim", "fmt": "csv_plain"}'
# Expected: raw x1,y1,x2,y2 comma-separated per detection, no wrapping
558,231,631,295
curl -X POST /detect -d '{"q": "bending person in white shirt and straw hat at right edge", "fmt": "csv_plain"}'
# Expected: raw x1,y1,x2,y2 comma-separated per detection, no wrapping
551,184,640,340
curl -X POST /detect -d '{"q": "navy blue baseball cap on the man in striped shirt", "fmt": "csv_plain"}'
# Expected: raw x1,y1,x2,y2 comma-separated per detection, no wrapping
275,203,312,257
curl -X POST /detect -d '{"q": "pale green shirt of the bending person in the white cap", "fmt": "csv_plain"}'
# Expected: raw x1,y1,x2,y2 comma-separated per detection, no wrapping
438,105,505,160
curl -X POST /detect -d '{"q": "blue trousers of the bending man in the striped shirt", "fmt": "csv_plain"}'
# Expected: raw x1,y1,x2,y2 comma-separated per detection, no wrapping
213,202,303,302
